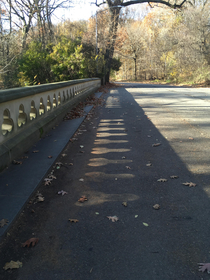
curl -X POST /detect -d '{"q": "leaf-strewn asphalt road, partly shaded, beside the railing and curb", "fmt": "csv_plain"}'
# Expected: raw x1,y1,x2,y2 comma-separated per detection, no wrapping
0,83,210,280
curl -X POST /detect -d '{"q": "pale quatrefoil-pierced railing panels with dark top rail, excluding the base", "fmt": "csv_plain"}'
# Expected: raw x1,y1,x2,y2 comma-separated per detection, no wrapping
0,79,100,143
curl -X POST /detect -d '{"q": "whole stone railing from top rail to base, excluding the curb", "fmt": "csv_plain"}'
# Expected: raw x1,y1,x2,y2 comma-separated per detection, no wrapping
0,78,101,170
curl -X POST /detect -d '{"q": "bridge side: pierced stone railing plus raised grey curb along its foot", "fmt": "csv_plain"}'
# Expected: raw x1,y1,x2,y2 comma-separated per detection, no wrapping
0,78,101,237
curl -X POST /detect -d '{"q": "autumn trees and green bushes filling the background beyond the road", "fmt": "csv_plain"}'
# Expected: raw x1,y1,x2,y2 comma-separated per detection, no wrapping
0,0,210,89
